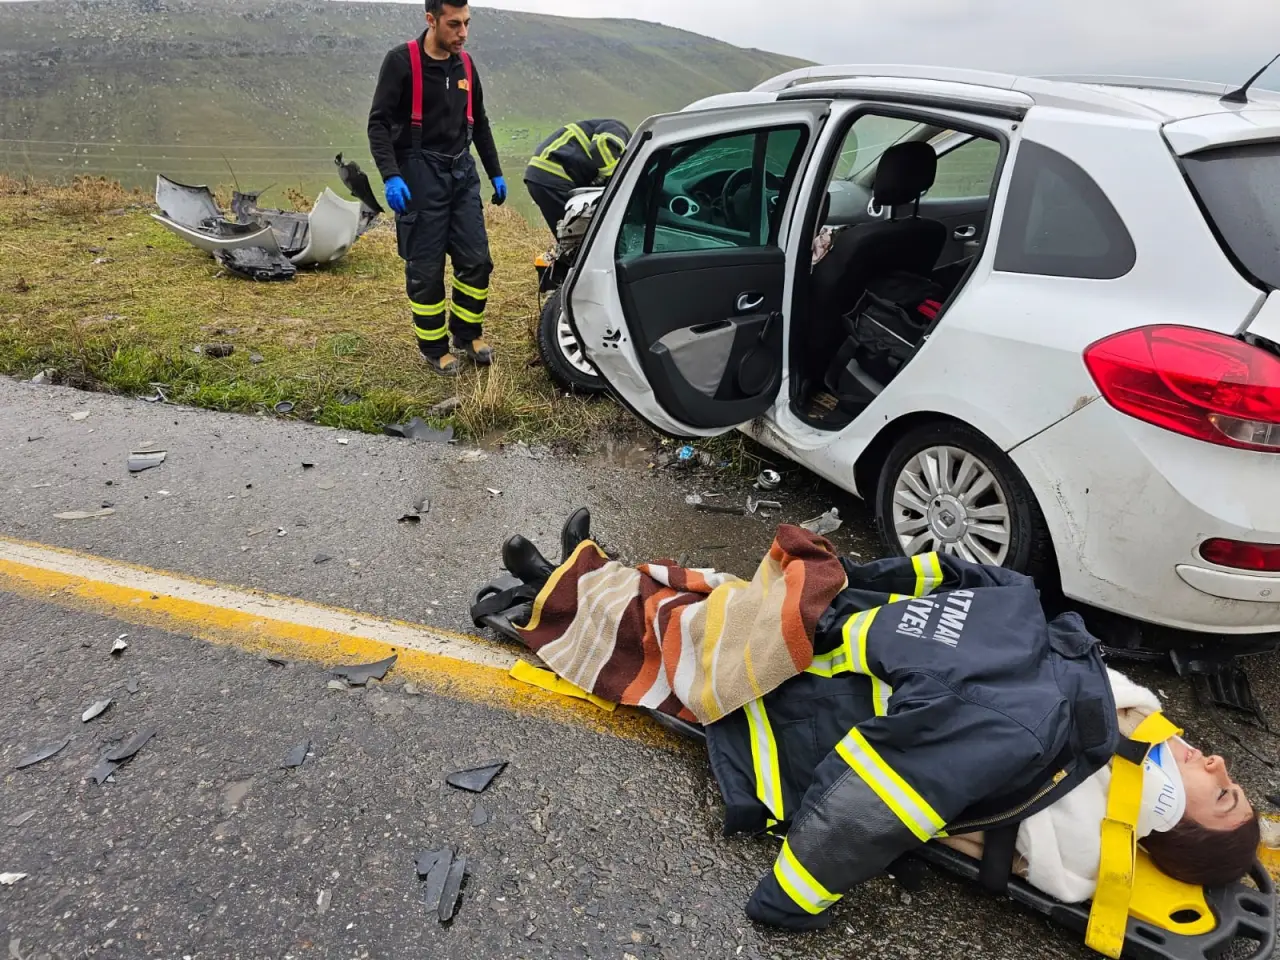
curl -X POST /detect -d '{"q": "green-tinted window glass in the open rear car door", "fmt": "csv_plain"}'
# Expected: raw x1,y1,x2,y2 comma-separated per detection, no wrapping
616,127,808,261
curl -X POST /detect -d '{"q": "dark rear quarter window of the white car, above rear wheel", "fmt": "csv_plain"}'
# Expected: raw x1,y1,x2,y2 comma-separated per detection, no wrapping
995,141,1137,280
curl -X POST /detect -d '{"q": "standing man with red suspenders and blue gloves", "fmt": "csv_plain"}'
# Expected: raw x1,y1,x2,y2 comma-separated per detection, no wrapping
369,0,507,376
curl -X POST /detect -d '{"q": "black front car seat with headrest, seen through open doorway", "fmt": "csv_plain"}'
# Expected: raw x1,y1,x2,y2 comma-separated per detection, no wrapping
809,142,947,379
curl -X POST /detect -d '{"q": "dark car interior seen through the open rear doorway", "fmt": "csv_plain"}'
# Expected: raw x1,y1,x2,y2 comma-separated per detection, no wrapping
791,115,1001,429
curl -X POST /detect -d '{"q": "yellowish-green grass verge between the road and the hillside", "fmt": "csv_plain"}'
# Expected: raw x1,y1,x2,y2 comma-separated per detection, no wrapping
0,175,639,449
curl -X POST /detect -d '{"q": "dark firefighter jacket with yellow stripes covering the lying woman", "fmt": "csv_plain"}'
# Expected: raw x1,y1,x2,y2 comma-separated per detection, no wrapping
707,554,1121,931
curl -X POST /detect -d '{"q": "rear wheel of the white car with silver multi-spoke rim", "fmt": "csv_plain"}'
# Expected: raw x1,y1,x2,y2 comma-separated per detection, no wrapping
876,422,1057,586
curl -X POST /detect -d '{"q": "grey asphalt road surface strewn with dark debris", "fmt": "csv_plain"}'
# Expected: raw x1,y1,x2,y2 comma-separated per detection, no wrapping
0,381,1280,960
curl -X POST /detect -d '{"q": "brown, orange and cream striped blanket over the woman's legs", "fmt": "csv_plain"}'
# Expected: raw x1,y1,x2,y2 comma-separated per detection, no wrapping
509,525,846,723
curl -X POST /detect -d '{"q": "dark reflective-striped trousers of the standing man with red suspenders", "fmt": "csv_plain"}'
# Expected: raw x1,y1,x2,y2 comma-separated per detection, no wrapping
396,151,493,357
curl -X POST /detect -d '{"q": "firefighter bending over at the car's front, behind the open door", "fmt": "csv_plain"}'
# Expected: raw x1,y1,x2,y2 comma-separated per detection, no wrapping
525,120,631,233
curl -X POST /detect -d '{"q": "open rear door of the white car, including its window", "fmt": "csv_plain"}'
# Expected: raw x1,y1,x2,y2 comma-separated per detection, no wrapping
564,101,829,436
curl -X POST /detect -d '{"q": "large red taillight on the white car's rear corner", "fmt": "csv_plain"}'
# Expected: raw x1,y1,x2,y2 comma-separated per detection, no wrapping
1084,326,1280,452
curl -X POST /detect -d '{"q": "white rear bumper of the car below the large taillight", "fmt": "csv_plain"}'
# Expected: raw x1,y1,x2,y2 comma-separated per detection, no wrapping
1010,399,1280,641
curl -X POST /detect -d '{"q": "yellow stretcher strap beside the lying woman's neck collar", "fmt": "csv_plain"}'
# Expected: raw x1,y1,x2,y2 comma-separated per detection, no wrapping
1084,712,1183,960
